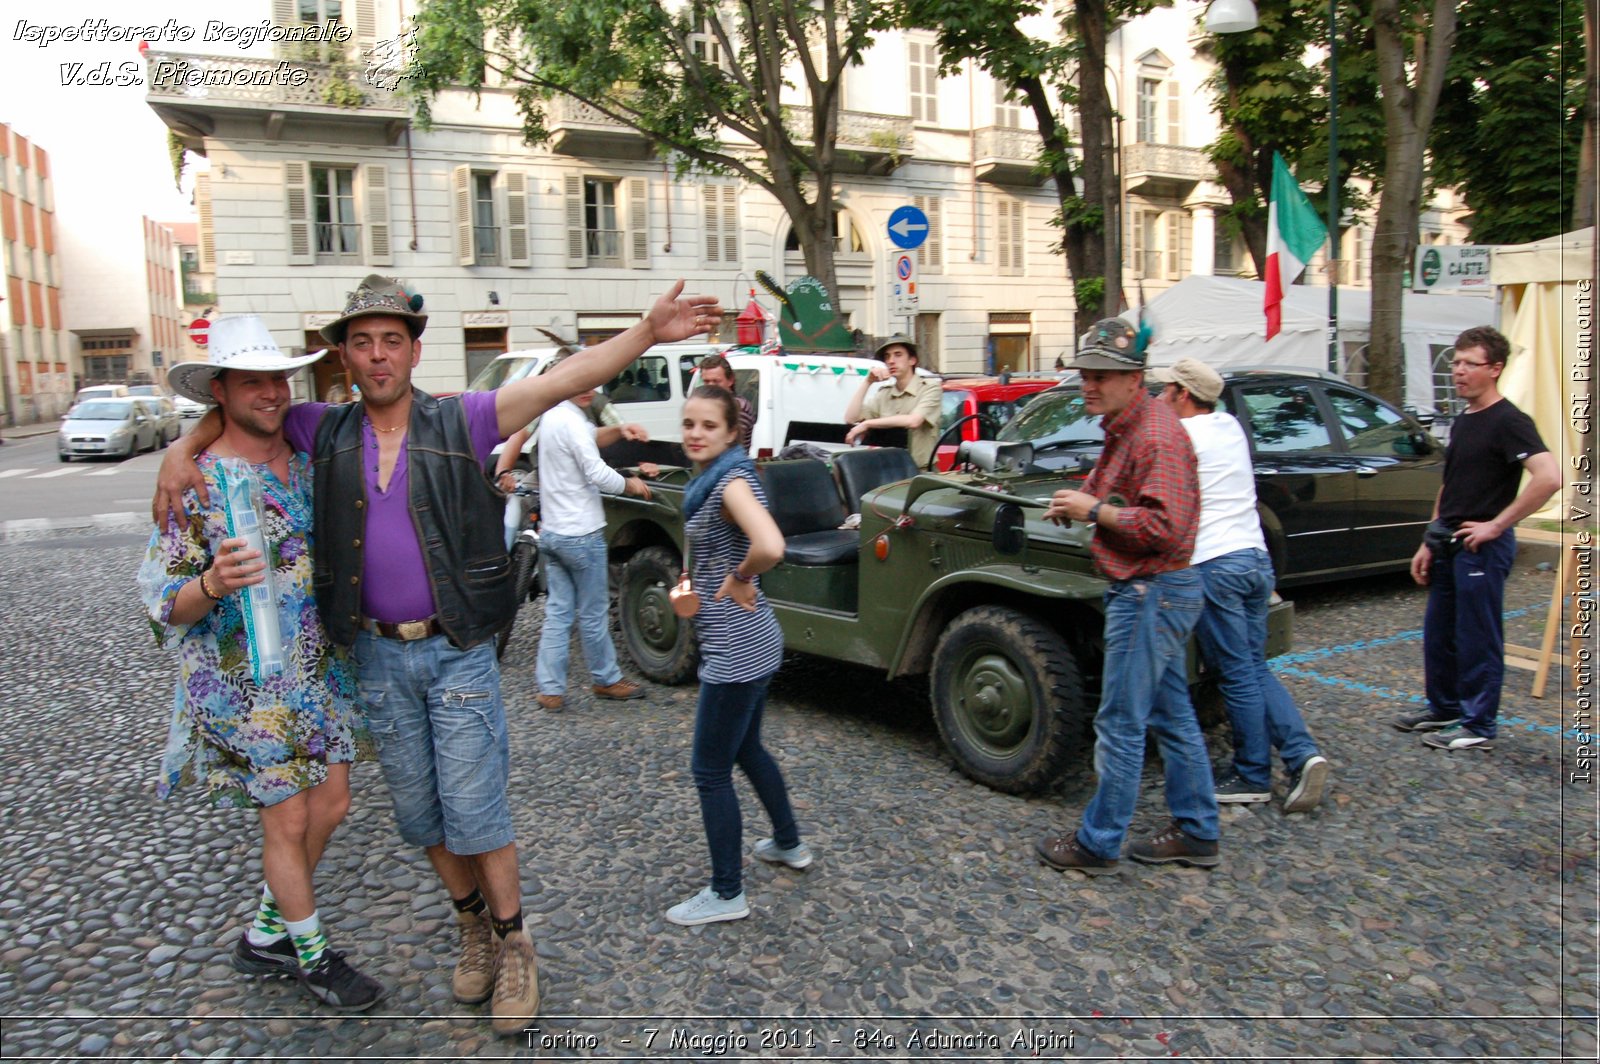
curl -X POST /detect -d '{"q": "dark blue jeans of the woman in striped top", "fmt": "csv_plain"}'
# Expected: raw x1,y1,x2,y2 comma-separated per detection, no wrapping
690,677,800,898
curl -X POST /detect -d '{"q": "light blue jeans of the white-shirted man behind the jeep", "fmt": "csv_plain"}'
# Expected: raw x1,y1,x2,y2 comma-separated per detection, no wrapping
534,530,622,694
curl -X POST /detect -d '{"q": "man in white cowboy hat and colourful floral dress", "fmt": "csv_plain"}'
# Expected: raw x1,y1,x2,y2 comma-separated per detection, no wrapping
139,315,384,1011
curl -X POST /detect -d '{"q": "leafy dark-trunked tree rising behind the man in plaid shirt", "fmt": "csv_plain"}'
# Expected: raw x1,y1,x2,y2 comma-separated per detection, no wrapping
896,0,1162,331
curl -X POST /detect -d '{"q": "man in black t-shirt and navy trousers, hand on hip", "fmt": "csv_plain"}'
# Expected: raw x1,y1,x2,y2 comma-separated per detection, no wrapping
1394,325,1562,750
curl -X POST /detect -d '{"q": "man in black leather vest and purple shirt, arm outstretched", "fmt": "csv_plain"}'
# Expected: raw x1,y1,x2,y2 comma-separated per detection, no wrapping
155,274,722,1034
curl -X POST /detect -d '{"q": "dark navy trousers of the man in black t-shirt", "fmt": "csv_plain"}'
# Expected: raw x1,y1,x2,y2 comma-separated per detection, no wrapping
1422,530,1517,739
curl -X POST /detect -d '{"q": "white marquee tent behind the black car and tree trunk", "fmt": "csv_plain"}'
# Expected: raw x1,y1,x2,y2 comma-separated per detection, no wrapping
1122,275,1494,410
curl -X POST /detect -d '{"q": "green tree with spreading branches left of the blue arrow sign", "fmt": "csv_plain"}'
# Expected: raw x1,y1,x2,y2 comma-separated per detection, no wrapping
408,0,886,291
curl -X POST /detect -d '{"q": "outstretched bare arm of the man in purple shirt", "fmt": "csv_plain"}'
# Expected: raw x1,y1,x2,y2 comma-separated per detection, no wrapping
494,280,722,435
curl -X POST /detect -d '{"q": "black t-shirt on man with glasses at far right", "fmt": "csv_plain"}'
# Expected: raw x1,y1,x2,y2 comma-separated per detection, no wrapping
1438,398,1550,526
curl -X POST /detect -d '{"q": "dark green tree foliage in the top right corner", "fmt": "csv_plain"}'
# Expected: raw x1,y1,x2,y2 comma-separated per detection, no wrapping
1430,0,1586,243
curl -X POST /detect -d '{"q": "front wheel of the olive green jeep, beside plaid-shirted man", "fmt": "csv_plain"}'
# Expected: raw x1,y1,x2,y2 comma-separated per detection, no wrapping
933,606,1088,794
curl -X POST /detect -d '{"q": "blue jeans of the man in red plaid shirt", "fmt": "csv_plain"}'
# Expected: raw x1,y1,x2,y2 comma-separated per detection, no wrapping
1078,570,1219,859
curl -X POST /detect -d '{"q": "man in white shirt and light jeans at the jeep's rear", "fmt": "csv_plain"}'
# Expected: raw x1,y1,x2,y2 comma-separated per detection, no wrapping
534,385,650,712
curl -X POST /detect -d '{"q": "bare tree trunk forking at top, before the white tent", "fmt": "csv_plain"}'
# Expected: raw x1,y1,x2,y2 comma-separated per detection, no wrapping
1366,0,1456,405
